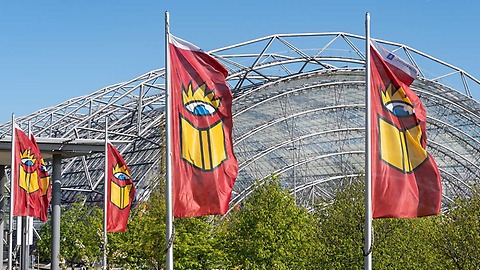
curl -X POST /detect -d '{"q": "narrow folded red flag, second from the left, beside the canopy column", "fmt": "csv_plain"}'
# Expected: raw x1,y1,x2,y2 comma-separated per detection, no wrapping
30,134,52,222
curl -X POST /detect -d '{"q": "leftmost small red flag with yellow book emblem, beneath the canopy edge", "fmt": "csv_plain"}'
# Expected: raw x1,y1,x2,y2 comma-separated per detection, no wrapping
12,127,47,222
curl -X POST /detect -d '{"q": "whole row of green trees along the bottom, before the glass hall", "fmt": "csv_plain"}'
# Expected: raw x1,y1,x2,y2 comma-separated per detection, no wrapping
37,174,480,269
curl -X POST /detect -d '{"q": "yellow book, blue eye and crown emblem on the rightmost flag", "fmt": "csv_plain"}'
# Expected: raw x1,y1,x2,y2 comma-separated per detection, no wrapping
378,85,427,173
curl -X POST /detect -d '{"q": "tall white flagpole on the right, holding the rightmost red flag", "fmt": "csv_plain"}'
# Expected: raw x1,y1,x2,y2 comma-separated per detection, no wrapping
363,12,373,270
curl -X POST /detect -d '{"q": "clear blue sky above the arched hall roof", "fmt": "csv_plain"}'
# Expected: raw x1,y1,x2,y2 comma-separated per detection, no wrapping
0,0,480,123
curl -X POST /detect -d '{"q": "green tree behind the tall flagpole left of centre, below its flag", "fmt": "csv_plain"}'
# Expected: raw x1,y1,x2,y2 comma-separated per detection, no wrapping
108,179,224,269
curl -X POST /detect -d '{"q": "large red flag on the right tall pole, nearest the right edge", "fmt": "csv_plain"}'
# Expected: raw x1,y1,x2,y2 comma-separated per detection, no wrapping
370,43,442,218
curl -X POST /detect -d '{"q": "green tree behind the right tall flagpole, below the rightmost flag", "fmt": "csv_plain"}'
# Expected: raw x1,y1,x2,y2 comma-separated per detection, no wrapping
317,178,445,269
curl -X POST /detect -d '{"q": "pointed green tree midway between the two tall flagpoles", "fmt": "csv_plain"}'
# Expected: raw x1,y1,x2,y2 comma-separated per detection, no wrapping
219,177,320,269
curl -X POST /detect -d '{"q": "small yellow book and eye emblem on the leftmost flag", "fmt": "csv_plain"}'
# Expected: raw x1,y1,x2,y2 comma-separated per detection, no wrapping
18,149,39,193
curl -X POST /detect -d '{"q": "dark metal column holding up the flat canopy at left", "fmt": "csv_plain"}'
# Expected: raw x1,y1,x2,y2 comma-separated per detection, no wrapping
51,154,62,270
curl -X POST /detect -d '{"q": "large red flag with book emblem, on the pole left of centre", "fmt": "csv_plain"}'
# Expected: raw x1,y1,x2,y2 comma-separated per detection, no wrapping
170,35,238,217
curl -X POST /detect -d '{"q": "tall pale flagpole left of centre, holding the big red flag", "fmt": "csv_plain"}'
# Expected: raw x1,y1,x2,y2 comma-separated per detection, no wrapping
165,11,173,270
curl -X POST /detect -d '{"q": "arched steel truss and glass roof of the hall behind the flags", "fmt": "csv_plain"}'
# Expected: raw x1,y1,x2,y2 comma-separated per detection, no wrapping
0,33,480,211
